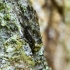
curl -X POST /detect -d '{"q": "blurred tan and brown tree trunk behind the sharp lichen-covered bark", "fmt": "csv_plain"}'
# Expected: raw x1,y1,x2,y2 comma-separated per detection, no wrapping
30,0,70,70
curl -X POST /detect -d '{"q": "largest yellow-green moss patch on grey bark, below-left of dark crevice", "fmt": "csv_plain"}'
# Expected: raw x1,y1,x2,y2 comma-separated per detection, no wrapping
4,35,35,66
